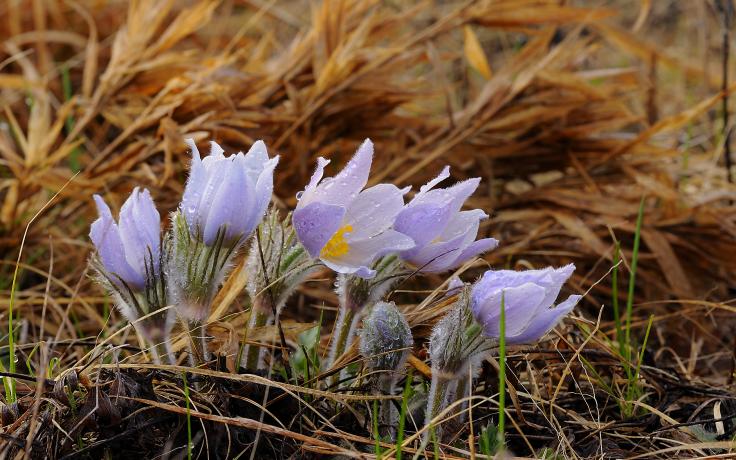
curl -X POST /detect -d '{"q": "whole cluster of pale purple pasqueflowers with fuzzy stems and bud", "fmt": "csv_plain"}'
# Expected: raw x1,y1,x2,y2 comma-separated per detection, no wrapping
90,135,579,436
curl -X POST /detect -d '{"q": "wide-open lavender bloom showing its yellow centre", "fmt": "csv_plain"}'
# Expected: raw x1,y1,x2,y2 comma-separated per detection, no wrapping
293,139,414,278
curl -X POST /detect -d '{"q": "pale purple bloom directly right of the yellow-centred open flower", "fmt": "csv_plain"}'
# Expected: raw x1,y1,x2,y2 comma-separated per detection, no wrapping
394,167,498,272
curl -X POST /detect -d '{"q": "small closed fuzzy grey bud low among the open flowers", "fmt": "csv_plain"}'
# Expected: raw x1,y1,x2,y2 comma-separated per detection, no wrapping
360,302,413,371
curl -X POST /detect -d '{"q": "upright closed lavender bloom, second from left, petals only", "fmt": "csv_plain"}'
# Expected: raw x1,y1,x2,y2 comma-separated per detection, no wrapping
181,139,279,246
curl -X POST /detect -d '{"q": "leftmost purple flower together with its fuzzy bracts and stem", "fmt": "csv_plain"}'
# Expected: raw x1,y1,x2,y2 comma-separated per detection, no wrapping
89,187,173,354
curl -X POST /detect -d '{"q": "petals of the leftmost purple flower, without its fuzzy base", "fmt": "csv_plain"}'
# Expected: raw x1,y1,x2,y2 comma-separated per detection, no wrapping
89,187,161,290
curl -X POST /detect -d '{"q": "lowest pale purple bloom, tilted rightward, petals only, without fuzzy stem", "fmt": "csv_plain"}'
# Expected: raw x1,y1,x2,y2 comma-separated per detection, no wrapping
470,264,582,345
